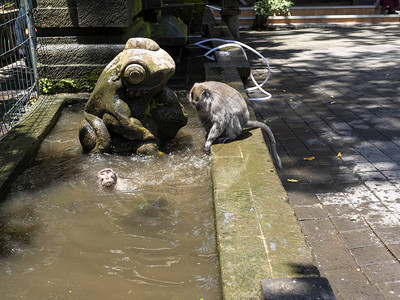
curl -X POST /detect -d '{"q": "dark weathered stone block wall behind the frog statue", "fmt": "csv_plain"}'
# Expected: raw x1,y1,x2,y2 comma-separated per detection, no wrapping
34,0,205,79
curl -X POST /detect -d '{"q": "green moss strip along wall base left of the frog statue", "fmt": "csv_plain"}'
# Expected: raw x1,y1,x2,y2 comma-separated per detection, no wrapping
39,68,103,94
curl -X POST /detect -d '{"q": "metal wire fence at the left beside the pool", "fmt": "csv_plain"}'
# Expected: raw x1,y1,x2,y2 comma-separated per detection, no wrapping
0,0,38,139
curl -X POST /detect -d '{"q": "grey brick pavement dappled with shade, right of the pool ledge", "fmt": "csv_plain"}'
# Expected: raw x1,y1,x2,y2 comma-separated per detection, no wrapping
241,26,400,300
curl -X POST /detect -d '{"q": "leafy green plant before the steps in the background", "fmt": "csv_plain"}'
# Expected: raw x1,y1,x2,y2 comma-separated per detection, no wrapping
253,0,293,29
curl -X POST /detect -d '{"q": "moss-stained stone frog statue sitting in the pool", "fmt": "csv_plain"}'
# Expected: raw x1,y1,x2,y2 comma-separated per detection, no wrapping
79,38,187,155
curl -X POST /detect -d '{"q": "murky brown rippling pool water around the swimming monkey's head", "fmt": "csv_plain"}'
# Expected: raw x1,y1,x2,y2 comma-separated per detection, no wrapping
0,99,220,299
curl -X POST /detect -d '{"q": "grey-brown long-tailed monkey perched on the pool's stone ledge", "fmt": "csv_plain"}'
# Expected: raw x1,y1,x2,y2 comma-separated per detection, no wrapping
189,81,282,169
